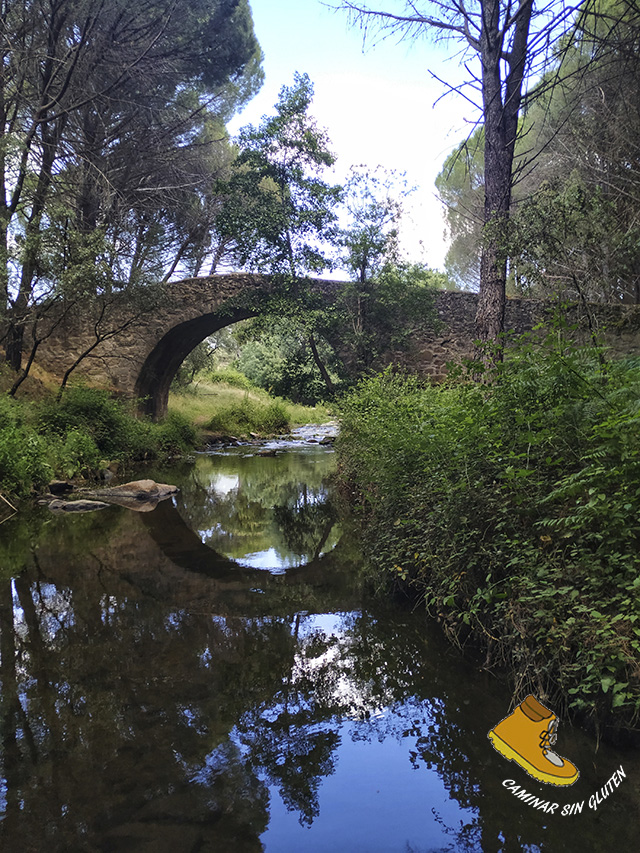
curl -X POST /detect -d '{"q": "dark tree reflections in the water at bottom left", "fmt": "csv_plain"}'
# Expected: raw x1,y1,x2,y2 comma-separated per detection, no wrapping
0,552,292,851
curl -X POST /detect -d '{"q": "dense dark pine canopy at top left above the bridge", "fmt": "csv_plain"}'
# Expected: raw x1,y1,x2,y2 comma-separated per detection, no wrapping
0,0,262,369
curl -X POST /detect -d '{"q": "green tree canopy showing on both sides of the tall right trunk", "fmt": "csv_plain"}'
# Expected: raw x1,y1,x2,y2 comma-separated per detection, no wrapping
437,0,640,302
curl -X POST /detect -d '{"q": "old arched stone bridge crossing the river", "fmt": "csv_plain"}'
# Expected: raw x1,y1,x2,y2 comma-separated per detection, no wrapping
36,273,640,418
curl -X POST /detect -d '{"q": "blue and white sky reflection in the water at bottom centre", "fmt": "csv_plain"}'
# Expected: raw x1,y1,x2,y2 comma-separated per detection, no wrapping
216,611,478,853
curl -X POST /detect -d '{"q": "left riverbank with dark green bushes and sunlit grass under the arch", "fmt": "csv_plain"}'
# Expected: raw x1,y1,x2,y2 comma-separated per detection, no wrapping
0,377,329,501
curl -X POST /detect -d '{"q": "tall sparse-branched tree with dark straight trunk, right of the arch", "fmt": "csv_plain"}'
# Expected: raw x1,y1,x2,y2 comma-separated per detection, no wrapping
338,0,589,352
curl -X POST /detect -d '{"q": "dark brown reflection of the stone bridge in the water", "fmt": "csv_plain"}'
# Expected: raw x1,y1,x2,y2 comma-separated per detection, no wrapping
36,500,361,618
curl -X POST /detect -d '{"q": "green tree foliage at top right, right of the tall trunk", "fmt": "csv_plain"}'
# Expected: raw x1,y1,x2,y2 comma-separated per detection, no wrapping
512,0,640,302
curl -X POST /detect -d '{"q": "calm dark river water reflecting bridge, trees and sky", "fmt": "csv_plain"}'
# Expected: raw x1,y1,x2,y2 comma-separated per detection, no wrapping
0,430,640,853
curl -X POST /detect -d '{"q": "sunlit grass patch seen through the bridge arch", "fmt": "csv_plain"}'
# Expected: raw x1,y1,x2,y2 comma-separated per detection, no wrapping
169,378,331,437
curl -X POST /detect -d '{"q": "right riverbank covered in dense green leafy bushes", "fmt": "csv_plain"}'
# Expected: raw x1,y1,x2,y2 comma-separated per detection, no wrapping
338,340,640,734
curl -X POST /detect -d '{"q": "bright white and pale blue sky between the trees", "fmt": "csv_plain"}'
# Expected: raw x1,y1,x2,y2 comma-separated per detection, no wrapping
228,0,477,269
